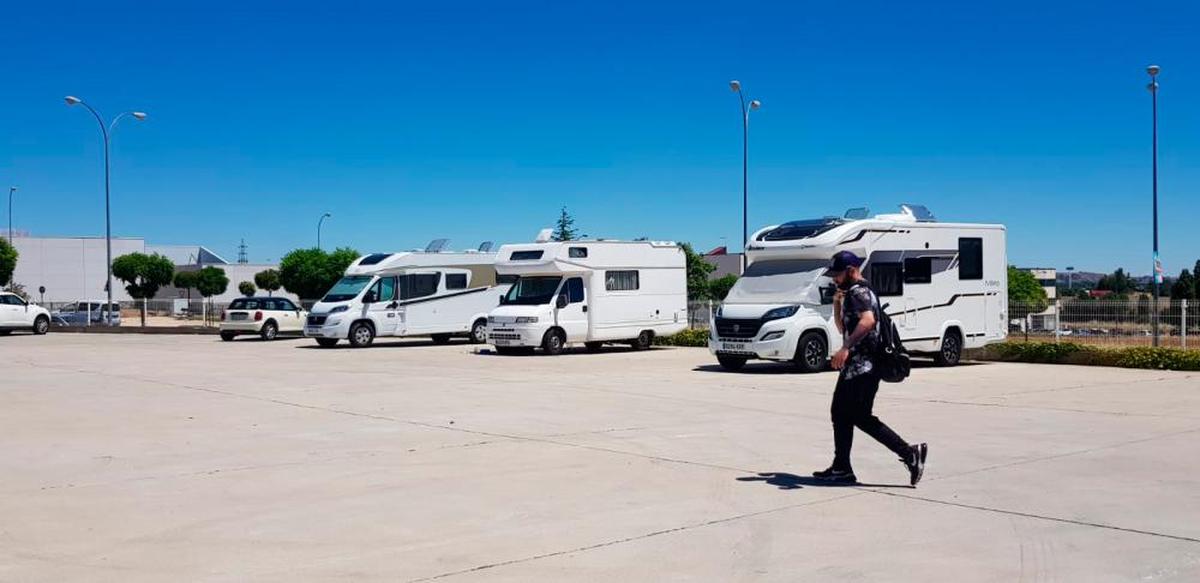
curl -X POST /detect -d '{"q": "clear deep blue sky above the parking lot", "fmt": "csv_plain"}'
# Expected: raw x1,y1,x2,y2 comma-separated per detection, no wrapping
0,1,1200,275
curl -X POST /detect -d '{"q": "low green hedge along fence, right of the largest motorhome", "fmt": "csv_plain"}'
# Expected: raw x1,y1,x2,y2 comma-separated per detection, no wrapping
972,342,1200,371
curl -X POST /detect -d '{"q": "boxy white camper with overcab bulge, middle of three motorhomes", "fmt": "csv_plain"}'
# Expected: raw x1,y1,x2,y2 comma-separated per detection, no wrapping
487,238,688,354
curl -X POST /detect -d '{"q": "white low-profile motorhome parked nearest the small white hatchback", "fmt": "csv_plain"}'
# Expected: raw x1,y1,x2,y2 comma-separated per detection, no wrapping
304,244,509,348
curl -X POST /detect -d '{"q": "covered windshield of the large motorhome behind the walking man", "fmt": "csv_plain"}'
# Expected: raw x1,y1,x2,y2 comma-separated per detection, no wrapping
725,259,829,306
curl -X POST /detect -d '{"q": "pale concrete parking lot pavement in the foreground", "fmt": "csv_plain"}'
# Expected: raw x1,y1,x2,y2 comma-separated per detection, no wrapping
0,333,1200,582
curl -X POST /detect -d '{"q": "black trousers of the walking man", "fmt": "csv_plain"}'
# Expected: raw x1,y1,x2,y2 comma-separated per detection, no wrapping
829,372,910,470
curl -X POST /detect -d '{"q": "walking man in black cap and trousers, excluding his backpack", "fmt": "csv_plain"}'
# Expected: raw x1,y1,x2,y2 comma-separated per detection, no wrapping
812,251,929,486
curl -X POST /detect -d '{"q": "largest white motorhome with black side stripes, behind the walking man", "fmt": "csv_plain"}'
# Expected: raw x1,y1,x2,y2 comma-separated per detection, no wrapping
708,204,1008,372
